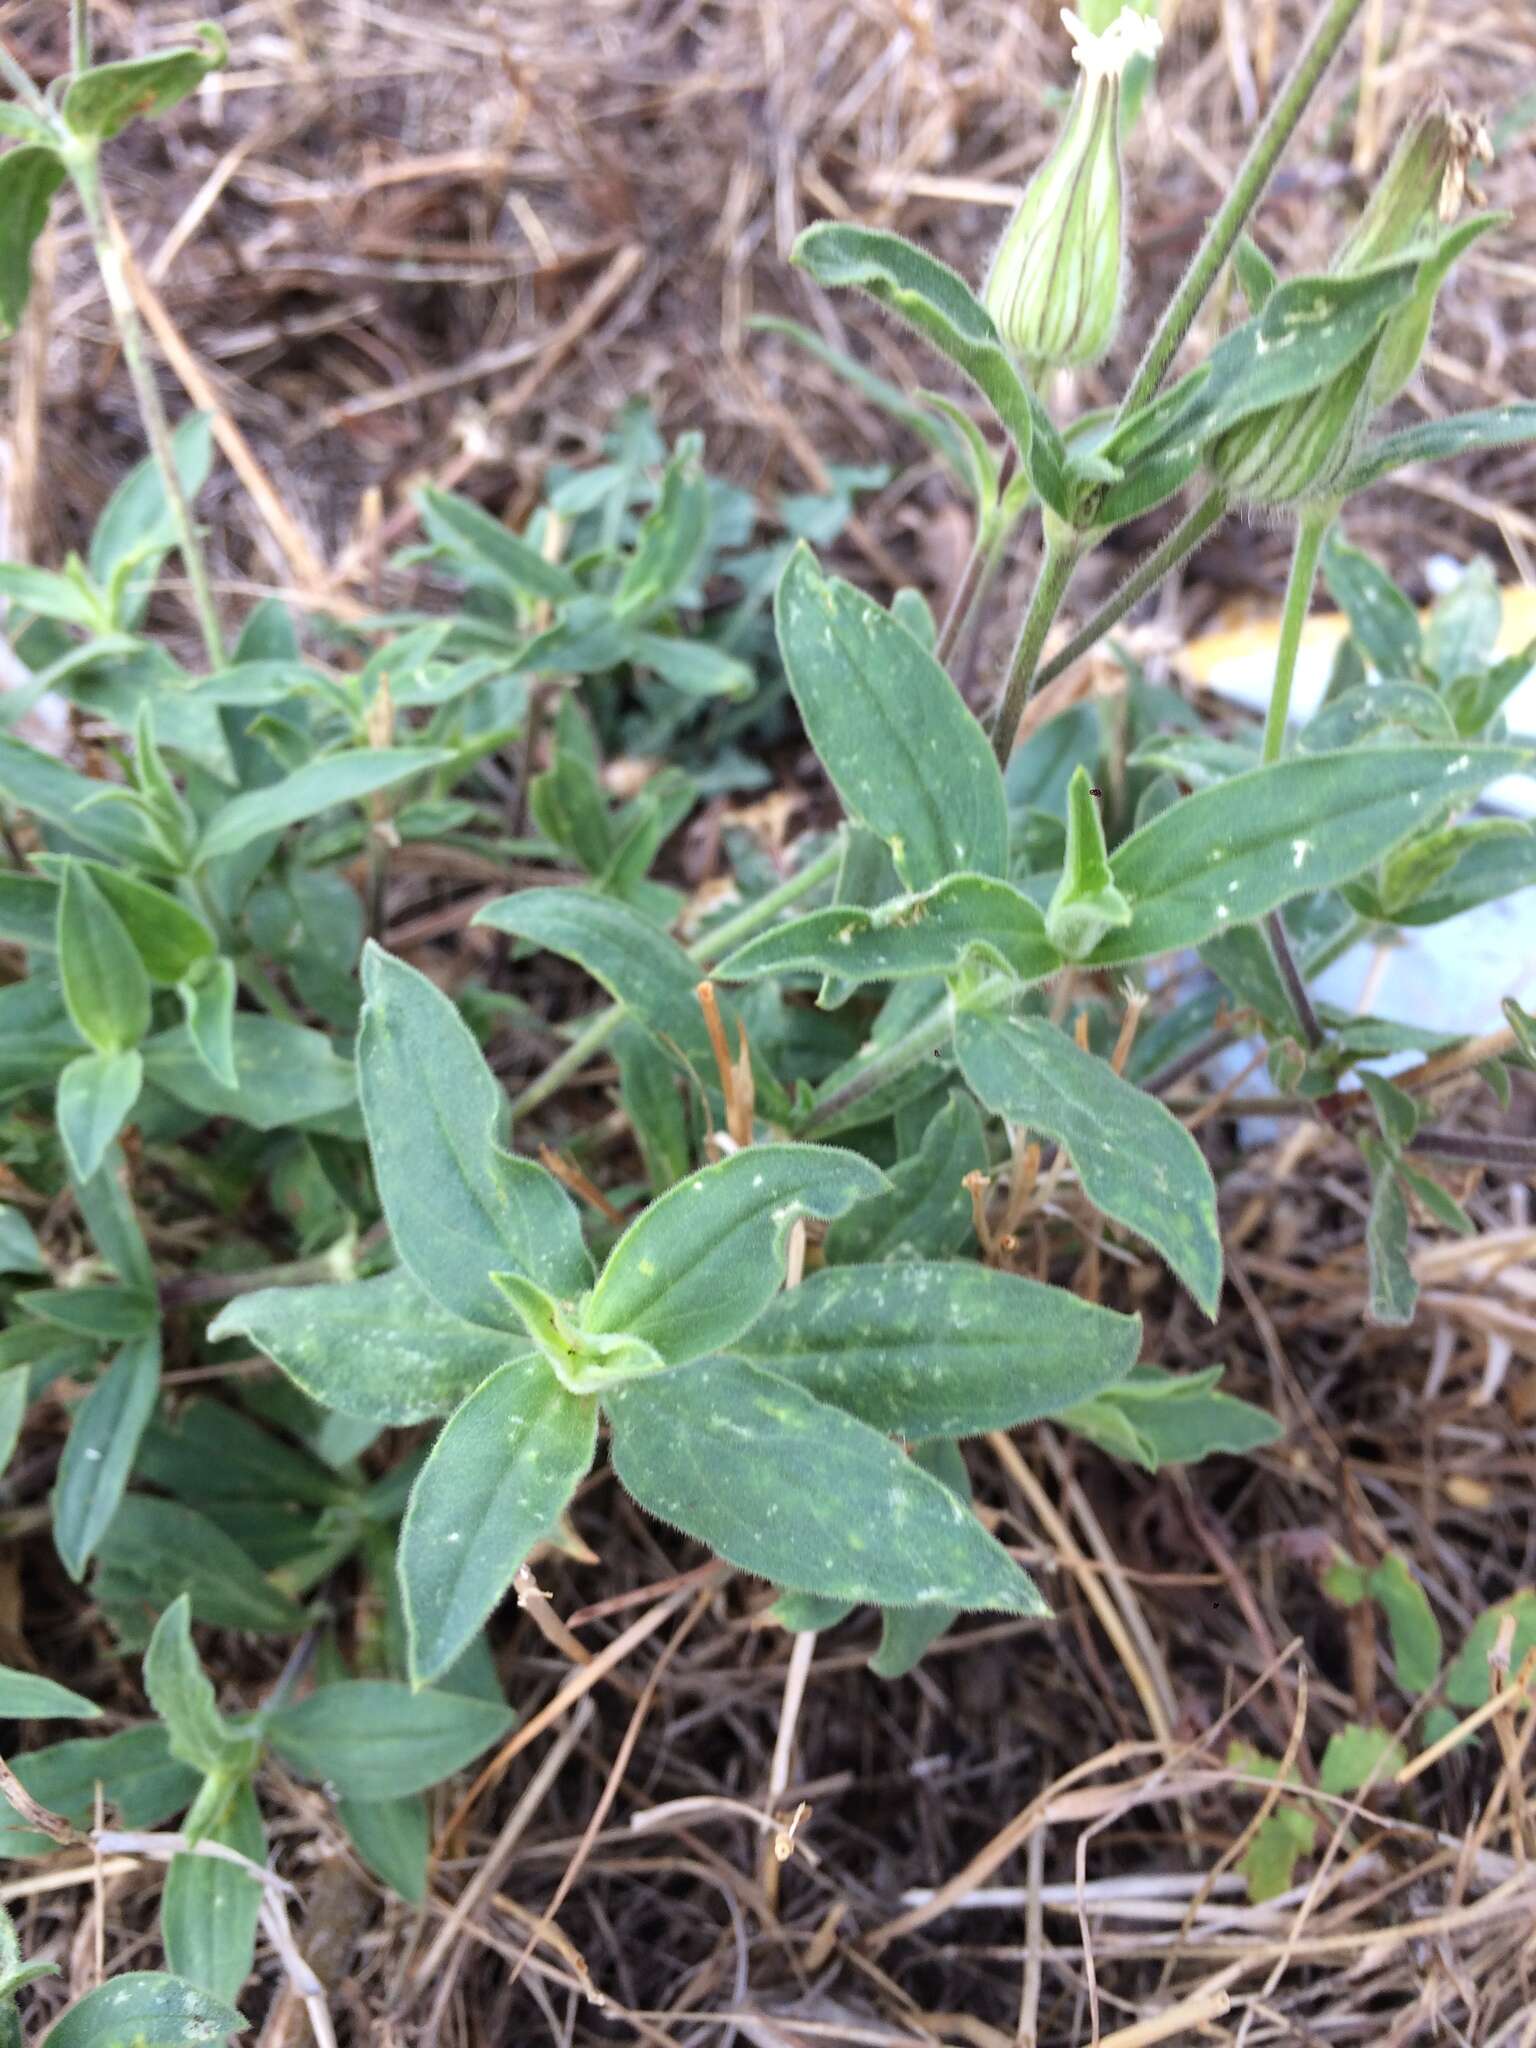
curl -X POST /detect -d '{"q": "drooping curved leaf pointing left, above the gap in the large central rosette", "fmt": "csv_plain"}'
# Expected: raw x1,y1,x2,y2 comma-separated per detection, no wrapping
475,889,737,1079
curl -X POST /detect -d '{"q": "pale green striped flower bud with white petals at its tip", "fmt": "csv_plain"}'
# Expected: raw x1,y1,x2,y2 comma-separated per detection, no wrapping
983,8,1161,371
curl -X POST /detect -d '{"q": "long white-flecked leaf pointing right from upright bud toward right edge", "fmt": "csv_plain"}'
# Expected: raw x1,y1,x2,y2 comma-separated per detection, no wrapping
1092,745,1530,967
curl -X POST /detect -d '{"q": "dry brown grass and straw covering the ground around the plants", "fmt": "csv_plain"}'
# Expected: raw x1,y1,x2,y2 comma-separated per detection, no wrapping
0,0,1536,2048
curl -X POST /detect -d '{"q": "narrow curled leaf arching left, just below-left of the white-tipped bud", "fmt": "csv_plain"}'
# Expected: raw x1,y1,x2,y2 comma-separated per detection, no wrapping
791,221,1071,518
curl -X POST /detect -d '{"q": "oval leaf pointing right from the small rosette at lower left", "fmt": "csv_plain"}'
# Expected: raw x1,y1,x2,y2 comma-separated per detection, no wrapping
266,1677,514,1798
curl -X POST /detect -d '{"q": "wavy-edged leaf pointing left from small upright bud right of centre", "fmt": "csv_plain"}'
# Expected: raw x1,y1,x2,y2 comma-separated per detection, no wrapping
715,874,1063,983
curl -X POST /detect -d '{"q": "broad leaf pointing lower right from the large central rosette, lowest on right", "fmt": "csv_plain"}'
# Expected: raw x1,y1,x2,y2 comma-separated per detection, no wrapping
606,1358,1047,1614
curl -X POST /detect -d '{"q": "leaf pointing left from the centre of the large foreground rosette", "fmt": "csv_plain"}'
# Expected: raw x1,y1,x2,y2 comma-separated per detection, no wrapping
209,1268,518,1423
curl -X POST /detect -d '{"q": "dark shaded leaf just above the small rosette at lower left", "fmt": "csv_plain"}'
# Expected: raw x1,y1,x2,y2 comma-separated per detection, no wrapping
96,1493,305,1636
